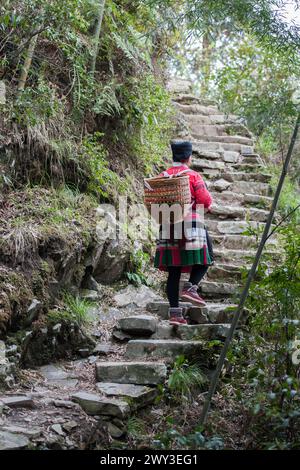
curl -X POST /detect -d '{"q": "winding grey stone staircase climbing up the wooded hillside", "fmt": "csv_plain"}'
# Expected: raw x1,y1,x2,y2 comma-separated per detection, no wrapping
67,81,276,436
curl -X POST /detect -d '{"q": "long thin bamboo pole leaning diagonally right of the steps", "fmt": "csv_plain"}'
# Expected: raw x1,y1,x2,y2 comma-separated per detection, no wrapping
200,113,300,425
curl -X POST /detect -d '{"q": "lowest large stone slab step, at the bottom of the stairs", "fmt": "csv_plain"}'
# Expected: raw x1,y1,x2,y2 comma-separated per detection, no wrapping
72,392,130,418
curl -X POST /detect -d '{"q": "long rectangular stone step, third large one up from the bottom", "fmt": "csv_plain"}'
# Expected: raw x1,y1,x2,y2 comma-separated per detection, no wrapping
96,361,167,385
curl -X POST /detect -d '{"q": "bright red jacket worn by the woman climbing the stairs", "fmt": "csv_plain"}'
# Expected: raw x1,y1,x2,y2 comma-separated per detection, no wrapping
160,163,213,209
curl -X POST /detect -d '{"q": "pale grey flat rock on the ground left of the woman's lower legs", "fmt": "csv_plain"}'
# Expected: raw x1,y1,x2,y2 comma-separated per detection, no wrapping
114,284,159,307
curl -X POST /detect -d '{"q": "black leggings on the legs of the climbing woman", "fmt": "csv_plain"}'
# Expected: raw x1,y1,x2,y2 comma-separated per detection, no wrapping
167,264,209,307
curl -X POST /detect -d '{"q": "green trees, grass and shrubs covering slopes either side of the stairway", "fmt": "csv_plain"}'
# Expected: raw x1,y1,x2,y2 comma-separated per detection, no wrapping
0,0,300,449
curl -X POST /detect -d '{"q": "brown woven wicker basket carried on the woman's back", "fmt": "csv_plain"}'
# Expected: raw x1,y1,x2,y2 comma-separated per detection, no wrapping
144,175,191,223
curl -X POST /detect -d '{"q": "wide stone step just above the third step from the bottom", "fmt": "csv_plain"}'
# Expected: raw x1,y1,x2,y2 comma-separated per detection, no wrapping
125,339,203,359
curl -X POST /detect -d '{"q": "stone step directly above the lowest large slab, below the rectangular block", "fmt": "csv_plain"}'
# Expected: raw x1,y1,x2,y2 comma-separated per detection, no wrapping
96,382,158,411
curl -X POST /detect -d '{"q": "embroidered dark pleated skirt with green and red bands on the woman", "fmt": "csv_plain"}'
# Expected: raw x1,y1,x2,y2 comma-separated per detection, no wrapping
154,220,213,272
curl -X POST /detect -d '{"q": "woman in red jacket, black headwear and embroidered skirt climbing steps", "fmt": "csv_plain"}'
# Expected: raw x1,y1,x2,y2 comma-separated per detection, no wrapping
154,141,213,325
